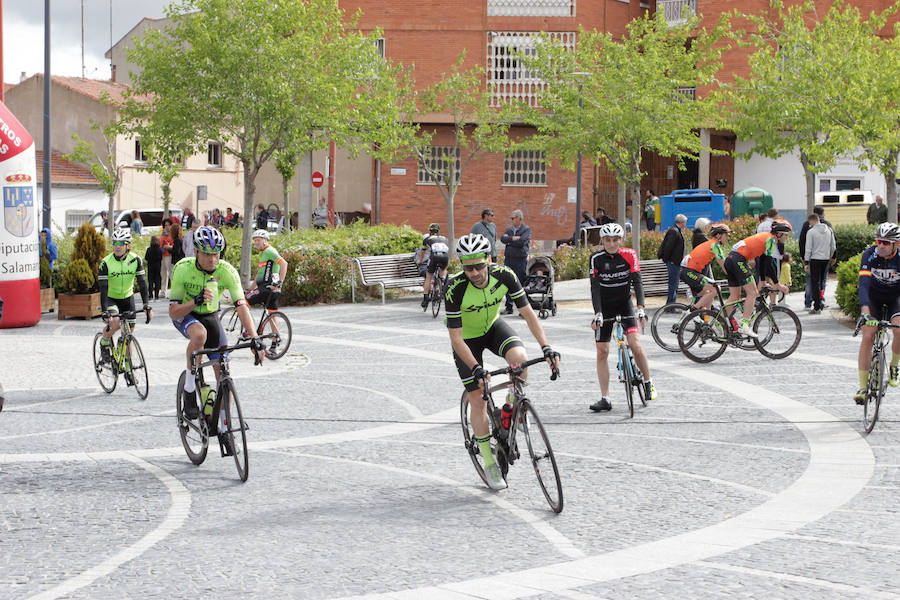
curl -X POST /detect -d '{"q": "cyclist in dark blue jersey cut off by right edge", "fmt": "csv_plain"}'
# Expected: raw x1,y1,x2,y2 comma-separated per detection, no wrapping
853,223,900,404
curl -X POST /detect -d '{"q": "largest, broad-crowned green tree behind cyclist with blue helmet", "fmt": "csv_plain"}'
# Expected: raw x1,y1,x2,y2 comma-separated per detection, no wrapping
121,0,410,283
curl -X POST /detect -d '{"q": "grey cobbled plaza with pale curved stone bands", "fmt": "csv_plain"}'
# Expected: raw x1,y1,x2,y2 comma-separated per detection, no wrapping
0,282,900,600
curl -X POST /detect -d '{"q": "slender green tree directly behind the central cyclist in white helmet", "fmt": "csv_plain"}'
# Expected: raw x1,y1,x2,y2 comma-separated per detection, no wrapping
409,52,515,247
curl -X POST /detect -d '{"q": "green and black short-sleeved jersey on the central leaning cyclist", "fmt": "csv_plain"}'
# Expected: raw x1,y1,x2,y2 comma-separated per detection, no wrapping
445,265,528,339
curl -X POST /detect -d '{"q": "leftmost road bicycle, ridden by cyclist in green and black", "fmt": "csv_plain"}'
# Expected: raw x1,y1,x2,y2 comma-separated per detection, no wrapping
93,309,150,400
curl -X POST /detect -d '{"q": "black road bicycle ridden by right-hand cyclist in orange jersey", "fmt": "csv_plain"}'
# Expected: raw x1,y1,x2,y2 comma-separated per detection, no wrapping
678,280,803,363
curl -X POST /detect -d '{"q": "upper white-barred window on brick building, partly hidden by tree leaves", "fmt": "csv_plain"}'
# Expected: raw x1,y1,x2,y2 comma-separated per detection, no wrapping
487,31,575,107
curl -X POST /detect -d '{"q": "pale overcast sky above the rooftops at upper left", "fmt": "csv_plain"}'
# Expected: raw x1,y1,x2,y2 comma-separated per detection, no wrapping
2,0,171,83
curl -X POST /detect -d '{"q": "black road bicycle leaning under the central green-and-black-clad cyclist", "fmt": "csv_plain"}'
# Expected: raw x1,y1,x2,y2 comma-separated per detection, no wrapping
460,357,563,513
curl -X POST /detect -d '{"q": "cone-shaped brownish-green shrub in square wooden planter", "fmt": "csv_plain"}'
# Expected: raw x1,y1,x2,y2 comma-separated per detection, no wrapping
57,223,106,319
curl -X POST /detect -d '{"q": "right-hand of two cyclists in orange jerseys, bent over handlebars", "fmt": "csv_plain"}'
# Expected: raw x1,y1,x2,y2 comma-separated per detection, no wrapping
724,220,791,337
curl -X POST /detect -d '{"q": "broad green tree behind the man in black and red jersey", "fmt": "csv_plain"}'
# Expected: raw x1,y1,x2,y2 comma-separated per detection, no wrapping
522,13,723,248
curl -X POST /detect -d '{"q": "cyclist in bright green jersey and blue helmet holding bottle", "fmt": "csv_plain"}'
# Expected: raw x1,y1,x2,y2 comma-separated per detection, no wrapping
169,225,263,420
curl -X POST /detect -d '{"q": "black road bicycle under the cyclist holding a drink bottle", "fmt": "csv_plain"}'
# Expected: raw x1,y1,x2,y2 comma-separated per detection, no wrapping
175,342,260,481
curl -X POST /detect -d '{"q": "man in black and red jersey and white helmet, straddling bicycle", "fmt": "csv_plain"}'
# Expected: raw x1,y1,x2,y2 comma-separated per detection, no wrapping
588,223,656,412
